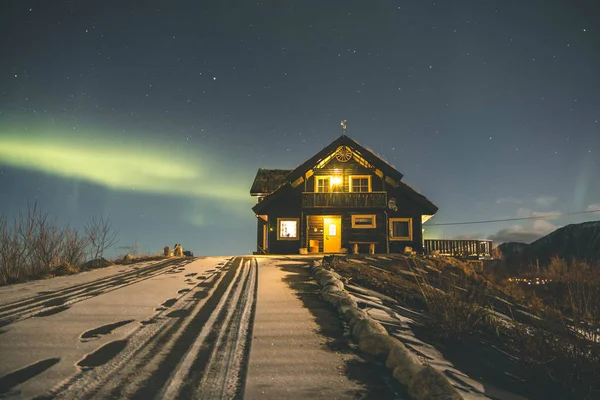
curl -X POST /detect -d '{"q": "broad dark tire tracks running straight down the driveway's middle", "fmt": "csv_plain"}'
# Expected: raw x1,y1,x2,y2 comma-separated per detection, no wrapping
51,257,257,399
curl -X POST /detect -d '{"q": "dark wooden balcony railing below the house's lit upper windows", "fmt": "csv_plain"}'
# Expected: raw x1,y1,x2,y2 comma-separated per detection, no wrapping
302,192,387,208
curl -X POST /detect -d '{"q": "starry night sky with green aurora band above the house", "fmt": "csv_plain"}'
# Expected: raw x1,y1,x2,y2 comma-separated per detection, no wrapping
0,0,600,255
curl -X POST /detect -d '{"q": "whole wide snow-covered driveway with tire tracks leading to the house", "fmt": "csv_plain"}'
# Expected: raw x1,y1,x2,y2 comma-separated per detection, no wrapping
0,256,400,399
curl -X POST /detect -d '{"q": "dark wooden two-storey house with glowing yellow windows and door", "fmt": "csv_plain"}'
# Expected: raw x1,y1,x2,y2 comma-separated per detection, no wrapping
250,135,438,254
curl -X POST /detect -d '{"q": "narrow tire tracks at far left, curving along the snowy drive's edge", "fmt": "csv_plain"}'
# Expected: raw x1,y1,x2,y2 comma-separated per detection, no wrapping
0,259,194,327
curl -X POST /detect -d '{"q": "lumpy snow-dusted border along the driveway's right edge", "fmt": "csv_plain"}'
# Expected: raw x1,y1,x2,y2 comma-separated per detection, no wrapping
310,260,462,400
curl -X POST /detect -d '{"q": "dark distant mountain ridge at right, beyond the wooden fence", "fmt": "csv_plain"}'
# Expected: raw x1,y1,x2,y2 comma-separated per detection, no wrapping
498,221,600,266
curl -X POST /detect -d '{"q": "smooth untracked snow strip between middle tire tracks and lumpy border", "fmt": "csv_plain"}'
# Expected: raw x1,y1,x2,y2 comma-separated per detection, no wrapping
245,257,405,399
